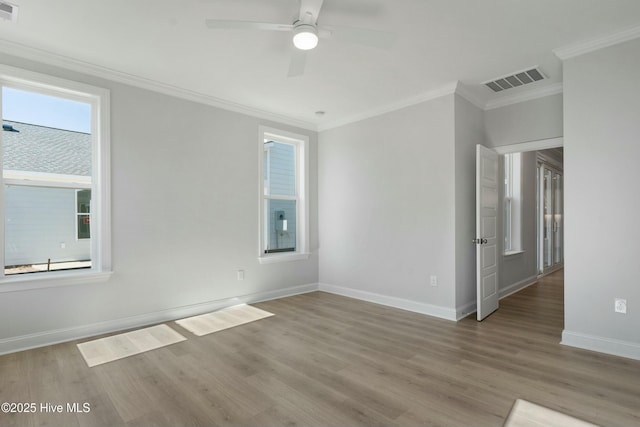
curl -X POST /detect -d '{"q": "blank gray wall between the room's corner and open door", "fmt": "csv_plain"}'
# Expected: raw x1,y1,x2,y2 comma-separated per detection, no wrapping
318,95,475,316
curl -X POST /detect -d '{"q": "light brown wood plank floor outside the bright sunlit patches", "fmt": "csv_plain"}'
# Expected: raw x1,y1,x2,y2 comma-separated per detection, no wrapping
0,272,640,427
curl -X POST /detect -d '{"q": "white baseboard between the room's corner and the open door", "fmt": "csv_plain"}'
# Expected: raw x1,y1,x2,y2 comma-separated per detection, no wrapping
318,283,457,321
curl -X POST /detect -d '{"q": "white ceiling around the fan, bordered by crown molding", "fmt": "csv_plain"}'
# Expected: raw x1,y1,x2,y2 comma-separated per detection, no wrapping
0,0,640,129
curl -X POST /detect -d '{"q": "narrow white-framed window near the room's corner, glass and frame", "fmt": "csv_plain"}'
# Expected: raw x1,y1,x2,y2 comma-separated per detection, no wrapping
259,128,308,263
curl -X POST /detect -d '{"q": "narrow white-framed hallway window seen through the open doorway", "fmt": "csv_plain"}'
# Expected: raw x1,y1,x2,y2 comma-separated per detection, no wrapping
504,153,522,255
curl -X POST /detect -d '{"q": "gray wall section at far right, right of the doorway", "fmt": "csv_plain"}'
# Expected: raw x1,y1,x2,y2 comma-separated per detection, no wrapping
563,36,640,358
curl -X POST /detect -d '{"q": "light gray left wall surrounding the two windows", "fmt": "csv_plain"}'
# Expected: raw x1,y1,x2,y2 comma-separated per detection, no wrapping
0,56,318,351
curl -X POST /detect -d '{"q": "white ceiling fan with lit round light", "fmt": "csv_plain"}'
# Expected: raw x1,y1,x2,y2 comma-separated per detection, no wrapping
205,0,395,77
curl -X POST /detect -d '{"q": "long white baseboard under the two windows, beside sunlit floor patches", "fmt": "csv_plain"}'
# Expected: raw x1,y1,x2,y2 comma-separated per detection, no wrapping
0,283,318,355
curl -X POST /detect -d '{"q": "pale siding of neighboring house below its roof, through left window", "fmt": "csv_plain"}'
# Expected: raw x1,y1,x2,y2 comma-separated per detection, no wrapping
4,186,91,266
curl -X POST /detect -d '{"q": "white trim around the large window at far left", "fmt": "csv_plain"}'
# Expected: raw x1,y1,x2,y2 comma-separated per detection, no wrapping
0,64,111,293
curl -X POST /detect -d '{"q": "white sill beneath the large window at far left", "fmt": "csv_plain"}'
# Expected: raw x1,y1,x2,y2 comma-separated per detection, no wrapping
0,271,112,293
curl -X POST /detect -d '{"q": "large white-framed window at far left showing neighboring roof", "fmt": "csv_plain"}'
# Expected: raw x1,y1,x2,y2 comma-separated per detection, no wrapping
0,65,111,292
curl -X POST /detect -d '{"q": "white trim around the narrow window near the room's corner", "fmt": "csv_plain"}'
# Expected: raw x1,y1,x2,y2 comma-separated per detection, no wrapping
258,126,309,264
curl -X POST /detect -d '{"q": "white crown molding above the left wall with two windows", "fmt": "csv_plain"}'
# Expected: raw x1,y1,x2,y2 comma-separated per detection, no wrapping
0,39,317,131
